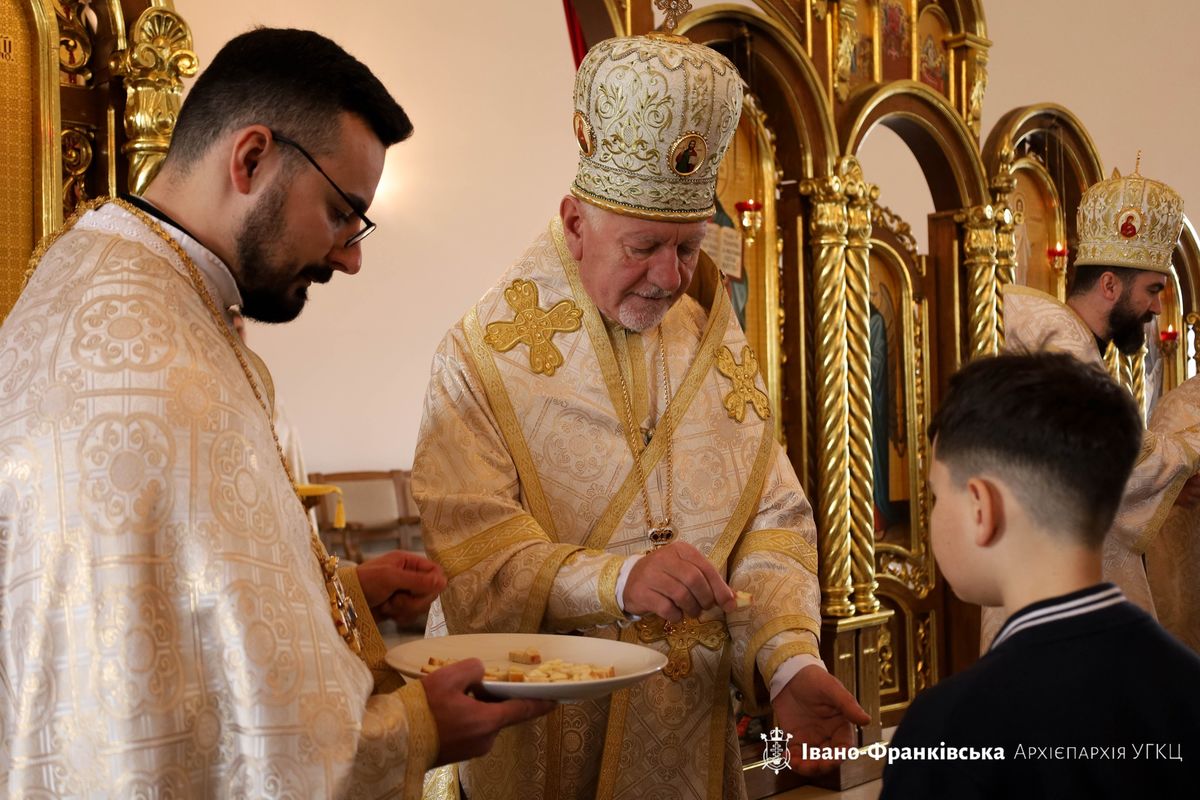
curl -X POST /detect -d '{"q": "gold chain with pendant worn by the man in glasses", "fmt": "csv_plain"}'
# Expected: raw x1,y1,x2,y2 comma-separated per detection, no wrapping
93,198,362,652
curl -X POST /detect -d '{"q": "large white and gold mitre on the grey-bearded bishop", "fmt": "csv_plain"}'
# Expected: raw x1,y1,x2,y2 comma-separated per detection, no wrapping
571,8,742,222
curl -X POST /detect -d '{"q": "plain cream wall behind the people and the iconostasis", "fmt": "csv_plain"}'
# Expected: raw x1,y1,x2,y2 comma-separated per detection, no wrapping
175,0,1200,471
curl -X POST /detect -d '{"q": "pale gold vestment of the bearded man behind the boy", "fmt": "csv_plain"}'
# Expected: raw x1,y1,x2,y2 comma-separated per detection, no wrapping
979,285,1200,650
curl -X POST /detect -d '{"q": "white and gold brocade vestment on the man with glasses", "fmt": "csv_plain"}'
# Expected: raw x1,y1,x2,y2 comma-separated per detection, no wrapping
0,204,437,798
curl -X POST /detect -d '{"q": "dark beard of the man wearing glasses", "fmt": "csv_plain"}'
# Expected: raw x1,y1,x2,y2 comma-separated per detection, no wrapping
236,185,334,323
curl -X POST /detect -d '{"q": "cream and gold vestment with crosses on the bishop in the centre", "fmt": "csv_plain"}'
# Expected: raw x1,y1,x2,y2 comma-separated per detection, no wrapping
413,219,820,800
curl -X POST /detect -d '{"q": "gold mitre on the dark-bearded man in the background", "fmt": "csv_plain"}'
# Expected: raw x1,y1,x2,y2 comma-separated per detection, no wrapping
1075,159,1183,272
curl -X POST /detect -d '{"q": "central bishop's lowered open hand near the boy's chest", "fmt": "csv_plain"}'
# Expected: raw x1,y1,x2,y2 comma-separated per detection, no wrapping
772,664,871,775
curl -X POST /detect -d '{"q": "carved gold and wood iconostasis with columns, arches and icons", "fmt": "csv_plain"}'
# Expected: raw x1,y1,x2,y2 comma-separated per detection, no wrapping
7,0,1200,796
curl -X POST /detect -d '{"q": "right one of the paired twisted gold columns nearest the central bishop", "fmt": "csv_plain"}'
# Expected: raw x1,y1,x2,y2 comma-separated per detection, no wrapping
838,156,880,614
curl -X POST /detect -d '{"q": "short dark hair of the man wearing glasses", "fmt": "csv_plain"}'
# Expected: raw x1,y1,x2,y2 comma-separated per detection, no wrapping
167,28,413,172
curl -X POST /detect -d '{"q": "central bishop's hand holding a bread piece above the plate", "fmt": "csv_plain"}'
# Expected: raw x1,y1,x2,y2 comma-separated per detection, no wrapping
623,541,737,622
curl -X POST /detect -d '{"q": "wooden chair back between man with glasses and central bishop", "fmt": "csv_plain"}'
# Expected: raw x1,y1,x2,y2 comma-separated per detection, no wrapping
308,469,425,564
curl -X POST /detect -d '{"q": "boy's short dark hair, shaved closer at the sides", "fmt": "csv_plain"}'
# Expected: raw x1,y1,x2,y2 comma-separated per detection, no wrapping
929,353,1142,547
